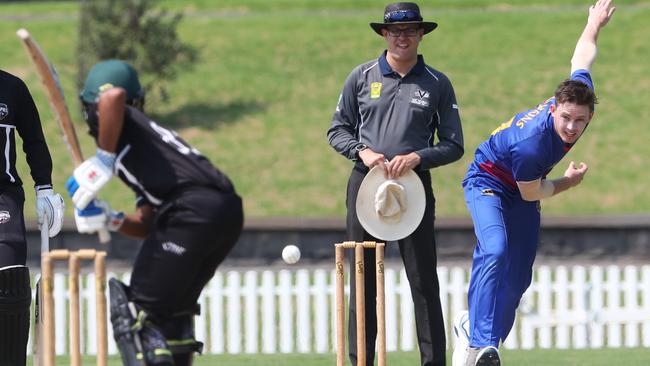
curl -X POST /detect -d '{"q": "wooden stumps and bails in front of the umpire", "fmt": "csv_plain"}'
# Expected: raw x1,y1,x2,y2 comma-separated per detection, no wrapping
334,241,386,366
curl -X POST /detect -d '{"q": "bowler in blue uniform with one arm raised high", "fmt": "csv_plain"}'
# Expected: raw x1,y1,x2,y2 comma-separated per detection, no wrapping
453,0,615,366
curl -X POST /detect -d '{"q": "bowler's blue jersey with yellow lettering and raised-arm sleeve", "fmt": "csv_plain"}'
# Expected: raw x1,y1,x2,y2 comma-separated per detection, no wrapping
463,70,594,195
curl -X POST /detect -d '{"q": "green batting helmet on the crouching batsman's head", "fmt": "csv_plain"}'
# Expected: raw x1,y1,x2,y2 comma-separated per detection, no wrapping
79,60,144,103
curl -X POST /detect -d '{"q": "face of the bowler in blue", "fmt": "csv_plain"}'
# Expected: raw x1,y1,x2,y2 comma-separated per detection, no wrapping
551,102,593,144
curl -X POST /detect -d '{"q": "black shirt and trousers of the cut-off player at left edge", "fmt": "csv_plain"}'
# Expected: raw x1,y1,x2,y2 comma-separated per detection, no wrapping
0,70,52,268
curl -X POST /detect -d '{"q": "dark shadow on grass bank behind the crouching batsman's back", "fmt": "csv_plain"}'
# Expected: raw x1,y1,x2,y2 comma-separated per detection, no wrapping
151,101,266,130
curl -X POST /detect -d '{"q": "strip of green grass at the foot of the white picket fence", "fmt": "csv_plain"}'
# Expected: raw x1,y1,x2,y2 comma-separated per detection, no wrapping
28,348,650,366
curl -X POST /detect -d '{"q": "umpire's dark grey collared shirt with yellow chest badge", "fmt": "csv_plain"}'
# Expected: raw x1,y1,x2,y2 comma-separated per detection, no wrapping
327,51,463,170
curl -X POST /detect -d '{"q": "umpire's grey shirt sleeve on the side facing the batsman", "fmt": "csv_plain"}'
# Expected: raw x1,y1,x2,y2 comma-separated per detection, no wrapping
327,69,360,160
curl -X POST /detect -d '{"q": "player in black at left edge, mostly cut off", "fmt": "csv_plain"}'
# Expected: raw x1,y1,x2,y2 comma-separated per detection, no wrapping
0,70,64,366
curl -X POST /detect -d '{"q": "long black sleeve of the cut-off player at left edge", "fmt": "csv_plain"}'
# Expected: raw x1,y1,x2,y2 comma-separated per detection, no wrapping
16,78,52,186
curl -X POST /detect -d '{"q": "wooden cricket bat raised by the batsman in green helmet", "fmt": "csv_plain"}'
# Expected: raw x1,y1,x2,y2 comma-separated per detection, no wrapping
16,28,111,244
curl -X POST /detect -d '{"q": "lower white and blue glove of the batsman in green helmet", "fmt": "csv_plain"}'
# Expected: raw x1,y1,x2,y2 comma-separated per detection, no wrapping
74,200,124,234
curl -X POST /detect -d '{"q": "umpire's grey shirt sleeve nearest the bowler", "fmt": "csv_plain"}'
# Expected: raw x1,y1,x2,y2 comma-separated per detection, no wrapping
416,78,464,169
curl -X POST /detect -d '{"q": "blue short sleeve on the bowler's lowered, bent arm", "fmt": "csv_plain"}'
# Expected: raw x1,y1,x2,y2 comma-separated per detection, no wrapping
510,135,549,182
